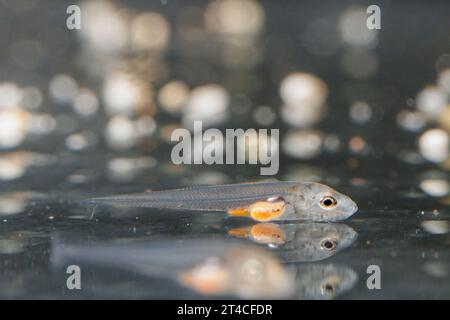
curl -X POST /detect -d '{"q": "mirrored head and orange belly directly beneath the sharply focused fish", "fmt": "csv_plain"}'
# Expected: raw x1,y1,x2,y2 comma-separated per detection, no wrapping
228,223,358,262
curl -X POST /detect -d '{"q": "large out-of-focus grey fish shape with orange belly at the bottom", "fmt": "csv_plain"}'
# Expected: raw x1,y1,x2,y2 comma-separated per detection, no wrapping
51,239,294,299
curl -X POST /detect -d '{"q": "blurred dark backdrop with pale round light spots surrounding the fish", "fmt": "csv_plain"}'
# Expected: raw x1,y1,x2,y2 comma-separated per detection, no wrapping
0,0,450,298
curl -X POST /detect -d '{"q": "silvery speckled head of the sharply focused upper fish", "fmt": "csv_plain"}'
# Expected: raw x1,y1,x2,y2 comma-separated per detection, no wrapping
290,183,358,221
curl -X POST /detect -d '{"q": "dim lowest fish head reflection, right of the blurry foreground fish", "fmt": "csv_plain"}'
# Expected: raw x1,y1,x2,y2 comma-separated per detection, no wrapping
296,264,358,300
